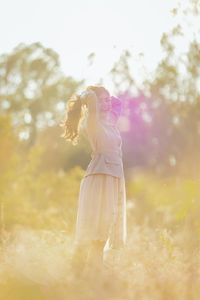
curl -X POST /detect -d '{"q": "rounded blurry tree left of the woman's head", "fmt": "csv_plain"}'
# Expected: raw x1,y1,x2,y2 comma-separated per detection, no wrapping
0,43,84,146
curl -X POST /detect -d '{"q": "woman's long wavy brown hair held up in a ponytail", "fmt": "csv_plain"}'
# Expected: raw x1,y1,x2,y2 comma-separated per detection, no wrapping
60,85,110,146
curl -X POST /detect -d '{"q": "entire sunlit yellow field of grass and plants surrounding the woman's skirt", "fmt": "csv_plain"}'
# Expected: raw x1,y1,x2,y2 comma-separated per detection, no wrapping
0,142,200,300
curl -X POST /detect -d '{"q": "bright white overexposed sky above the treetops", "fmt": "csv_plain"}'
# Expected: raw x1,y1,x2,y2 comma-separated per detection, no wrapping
0,0,180,92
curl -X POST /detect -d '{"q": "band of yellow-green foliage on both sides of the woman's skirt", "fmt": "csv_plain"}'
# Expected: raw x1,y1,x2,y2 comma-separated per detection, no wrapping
0,111,200,243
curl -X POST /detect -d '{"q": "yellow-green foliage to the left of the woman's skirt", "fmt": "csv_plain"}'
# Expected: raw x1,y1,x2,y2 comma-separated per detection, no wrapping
0,117,84,232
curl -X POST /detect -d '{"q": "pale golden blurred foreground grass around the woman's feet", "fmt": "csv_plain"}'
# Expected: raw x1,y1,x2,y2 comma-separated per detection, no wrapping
0,218,200,300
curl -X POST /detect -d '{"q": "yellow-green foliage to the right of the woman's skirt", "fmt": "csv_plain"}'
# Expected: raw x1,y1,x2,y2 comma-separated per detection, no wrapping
127,172,200,232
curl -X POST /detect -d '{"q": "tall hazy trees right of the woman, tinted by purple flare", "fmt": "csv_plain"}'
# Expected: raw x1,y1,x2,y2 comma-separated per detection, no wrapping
108,0,200,177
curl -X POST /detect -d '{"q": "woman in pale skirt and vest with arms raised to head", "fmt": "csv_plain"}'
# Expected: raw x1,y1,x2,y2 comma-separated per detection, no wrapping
60,86,126,274
